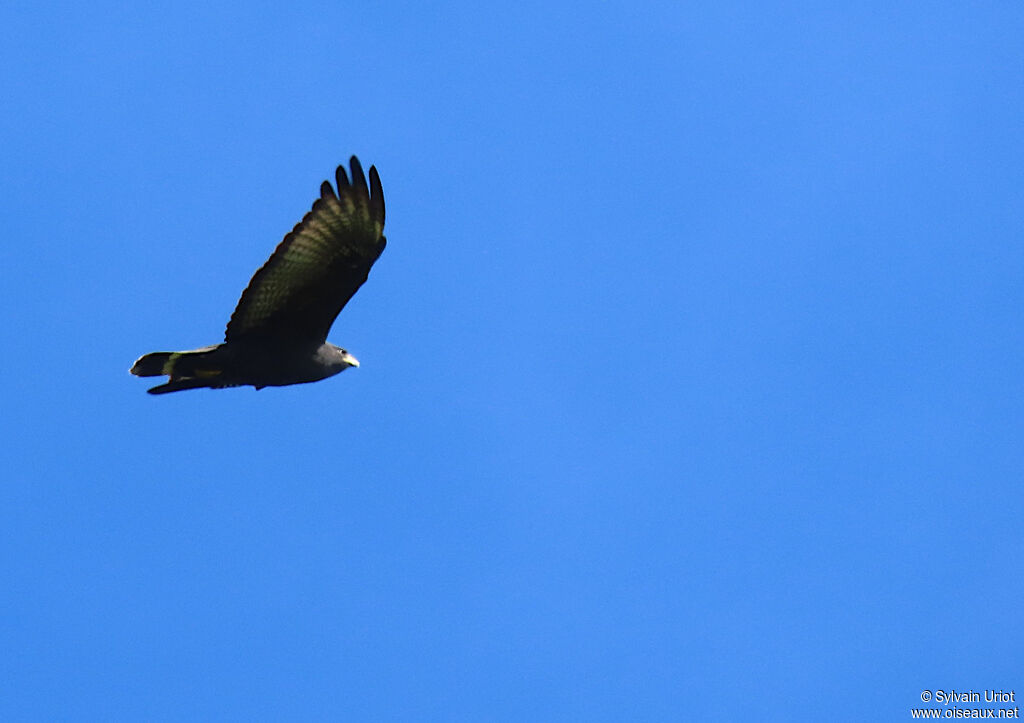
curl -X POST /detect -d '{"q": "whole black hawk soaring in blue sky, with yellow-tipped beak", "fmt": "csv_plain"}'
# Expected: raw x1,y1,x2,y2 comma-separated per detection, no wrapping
130,156,387,394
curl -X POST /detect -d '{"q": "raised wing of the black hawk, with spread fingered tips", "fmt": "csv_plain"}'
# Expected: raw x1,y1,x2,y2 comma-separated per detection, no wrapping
224,156,386,344
